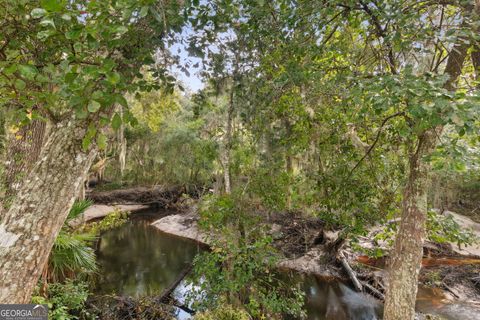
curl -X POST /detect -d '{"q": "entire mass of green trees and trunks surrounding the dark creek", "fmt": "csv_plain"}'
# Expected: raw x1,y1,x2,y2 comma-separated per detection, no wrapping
0,0,480,320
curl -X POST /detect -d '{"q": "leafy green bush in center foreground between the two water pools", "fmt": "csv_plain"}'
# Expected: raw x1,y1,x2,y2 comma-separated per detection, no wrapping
190,191,303,319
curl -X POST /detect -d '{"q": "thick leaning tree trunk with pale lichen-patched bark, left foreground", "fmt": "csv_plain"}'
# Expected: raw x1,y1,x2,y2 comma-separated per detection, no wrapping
0,122,96,303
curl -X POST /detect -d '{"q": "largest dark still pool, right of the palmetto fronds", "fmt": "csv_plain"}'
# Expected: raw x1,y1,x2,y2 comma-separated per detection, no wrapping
96,220,201,297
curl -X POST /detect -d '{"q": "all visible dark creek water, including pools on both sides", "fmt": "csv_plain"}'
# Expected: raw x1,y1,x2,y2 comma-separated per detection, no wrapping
96,219,480,320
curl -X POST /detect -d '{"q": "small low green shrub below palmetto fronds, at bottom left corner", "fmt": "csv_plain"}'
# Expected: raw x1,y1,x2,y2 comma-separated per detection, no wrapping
32,280,94,320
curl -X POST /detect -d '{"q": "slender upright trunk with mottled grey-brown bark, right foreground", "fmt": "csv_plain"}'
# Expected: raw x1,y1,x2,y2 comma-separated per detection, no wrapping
384,130,436,320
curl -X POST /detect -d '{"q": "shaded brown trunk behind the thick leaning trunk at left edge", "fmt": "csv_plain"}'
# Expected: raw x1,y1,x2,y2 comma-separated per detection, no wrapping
4,120,47,202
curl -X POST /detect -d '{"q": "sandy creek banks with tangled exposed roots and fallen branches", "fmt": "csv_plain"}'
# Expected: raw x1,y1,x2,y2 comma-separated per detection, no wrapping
81,185,480,318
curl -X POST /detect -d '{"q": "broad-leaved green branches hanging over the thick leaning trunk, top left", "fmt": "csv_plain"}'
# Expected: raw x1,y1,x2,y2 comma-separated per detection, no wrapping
0,0,183,149
